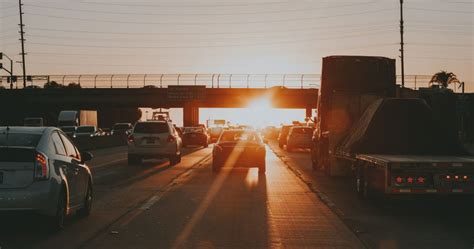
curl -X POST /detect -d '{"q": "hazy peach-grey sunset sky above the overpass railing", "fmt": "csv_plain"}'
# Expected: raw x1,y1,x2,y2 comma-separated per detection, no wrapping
0,0,474,91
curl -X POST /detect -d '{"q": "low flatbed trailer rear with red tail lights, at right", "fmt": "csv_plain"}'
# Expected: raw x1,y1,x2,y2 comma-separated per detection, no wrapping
352,154,474,198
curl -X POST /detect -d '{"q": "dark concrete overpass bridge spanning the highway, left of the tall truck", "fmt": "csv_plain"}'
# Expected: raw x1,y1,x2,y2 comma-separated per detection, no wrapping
0,85,318,126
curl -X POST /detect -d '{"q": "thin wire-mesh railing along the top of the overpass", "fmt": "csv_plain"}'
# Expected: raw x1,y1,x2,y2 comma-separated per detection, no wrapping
0,74,467,92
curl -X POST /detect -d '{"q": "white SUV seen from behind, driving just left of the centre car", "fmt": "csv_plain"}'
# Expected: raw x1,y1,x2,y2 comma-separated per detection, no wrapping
128,120,183,165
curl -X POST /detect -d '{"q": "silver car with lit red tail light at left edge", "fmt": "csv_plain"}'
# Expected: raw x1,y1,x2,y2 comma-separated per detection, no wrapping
0,127,92,228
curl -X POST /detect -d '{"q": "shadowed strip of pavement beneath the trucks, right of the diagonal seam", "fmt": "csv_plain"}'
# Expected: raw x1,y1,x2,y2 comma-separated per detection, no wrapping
270,142,474,249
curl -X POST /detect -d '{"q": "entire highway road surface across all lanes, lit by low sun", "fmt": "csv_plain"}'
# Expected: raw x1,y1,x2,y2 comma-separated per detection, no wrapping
0,143,474,249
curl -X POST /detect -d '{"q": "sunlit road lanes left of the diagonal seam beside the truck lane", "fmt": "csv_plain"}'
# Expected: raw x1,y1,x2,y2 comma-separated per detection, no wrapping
0,145,363,249
